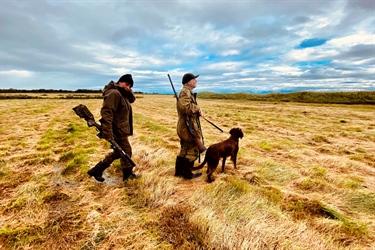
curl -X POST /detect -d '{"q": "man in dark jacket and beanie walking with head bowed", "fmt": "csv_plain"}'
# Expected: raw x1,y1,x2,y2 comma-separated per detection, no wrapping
87,74,136,182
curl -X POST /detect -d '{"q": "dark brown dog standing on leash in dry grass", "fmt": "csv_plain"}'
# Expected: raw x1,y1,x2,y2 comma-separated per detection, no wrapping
191,128,243,182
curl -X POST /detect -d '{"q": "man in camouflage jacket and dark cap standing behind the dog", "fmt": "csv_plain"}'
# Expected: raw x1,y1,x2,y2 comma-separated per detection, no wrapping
175,73,203,179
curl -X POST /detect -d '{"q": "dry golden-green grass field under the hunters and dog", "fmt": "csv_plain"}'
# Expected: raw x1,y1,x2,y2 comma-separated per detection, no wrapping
0,95,375,250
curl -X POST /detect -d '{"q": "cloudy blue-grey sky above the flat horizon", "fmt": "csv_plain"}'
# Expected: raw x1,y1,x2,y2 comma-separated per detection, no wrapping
0,0,375,93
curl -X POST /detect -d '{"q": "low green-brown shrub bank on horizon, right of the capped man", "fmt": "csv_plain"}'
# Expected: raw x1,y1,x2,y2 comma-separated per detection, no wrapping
198,91,375,104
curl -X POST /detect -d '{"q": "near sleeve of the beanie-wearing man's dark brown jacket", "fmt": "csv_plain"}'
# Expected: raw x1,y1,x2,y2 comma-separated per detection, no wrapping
100,91,120,140
